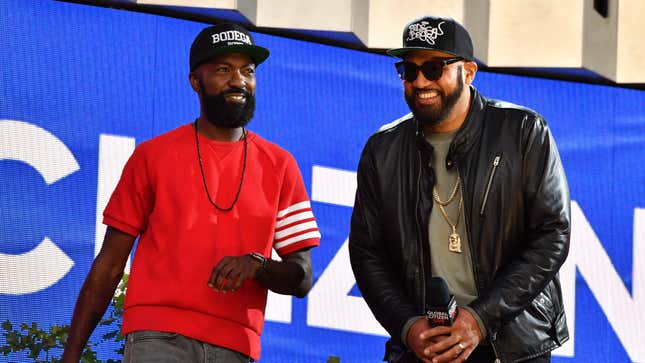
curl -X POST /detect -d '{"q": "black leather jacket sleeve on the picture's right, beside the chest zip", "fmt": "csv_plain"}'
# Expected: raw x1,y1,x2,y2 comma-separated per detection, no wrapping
471,116,571,334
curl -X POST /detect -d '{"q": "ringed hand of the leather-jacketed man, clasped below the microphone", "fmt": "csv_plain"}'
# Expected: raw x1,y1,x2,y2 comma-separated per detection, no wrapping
420,308,483,363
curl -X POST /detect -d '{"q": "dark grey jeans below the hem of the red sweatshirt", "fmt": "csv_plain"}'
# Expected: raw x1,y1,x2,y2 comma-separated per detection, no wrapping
123,330,251,363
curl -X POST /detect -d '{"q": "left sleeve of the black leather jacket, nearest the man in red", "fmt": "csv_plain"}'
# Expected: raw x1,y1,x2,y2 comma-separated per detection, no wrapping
349,142,421,342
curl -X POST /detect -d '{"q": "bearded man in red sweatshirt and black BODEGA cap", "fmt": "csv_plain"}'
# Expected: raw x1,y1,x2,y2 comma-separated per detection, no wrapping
63,24,320,363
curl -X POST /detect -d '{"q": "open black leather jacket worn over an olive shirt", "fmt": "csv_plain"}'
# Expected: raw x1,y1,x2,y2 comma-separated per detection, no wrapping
349,87,570,362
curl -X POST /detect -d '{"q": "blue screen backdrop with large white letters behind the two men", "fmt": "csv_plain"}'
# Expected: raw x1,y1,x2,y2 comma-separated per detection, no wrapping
0,0,645,363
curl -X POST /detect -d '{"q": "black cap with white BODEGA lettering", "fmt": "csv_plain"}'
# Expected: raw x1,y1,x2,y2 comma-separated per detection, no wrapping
190,23,269,71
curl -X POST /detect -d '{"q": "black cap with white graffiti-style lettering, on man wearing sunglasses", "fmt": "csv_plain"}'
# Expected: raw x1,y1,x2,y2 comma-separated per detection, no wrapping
387,16,475,61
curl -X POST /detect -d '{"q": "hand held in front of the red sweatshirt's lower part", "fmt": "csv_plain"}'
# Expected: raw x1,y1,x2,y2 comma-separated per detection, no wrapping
208,255,260,293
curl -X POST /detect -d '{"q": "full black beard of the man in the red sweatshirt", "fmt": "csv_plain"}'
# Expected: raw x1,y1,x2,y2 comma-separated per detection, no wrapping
199,80,255,129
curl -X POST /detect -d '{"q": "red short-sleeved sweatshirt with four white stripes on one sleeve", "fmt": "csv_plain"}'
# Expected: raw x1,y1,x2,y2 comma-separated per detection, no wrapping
103,125,320,360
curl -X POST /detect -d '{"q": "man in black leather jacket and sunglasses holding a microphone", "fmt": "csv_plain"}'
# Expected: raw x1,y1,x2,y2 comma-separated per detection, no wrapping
349,17,570,363
